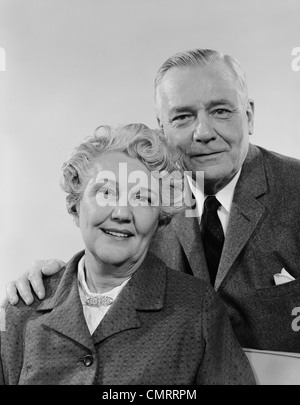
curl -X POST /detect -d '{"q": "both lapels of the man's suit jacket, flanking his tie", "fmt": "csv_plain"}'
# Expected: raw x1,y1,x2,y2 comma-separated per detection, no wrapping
172,144,268,290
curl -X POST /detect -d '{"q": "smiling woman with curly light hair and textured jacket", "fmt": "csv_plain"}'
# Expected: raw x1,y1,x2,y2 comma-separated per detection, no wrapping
0,124,255,385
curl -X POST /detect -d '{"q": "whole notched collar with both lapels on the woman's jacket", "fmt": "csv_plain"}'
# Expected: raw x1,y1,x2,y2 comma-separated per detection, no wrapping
37,251,166,350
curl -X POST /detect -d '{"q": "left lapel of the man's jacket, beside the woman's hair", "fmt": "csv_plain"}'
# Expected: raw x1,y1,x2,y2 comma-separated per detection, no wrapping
172,212,209,281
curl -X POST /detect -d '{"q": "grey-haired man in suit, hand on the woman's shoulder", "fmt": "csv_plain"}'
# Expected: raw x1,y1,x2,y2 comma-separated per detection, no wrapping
3,49,300,352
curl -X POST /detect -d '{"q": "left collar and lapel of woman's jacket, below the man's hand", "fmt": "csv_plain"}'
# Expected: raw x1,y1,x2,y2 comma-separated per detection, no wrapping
37,252,94,350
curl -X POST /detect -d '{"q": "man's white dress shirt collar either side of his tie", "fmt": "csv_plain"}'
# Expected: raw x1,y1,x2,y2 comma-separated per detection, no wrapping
187,169,241,236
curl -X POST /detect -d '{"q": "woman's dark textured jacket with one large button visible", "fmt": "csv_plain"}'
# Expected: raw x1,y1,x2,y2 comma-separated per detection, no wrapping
0,252,255,385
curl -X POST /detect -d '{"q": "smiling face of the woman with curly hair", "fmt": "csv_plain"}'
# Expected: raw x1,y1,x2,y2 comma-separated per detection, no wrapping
78,152,160,266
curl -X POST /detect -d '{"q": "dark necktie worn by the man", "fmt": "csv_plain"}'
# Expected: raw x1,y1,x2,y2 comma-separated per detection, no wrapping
201,196,224,285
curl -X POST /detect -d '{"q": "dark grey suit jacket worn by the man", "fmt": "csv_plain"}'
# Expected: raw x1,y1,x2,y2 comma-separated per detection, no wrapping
151,145,300,352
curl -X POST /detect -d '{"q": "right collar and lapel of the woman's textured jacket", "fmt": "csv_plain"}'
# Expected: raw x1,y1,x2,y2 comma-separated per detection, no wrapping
93,252,166,344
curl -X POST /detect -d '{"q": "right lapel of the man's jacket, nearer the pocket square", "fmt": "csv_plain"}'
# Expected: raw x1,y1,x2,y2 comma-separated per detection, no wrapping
215,145,267,290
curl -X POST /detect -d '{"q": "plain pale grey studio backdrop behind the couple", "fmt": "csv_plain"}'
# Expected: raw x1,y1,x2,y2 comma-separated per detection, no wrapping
0,0,300,295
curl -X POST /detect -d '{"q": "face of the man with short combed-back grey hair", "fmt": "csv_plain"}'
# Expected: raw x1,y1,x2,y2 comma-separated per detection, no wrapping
156,62,254,194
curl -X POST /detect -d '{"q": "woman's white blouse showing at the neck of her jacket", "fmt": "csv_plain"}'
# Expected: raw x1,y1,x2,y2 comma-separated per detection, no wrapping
77,256,130,335
